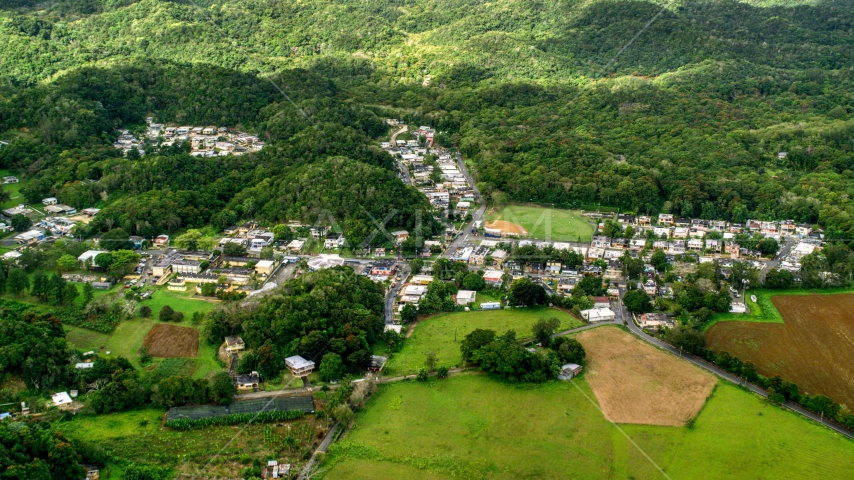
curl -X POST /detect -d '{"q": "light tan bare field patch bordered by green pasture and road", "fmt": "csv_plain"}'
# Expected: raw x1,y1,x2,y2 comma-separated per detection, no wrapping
578,327,717,426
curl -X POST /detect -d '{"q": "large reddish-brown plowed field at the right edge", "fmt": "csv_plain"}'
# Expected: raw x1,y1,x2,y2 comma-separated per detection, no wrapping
706,294,854,406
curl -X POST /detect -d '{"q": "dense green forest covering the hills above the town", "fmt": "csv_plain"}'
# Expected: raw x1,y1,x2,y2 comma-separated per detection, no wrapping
0,0,854,236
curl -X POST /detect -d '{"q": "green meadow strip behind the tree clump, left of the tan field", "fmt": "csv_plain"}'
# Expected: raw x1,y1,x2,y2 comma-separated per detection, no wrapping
383,307,583,376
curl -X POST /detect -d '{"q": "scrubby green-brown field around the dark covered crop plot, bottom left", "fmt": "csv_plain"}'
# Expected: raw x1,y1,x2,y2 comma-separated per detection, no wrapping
53,408,326,480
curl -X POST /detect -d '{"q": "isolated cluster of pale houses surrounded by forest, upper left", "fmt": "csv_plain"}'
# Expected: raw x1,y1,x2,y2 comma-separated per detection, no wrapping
113,117,264,157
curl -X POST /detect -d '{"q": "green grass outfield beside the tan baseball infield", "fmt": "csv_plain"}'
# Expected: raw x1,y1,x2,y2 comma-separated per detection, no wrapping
487,205,593,242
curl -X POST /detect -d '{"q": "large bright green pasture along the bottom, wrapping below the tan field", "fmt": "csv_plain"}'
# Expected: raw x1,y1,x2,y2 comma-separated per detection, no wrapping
322,374,854,479
